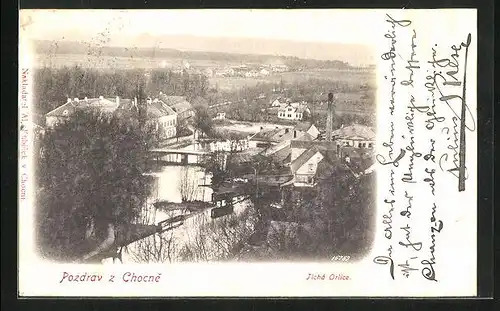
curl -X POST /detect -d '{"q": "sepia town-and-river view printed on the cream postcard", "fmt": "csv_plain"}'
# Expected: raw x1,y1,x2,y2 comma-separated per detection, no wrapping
23,11,376,263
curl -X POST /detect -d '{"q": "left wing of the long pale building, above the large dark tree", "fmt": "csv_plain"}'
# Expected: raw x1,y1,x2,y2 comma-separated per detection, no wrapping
45,96,120,128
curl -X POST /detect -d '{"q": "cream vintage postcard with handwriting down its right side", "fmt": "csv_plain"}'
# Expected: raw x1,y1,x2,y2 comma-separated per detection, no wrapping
18,9,477,297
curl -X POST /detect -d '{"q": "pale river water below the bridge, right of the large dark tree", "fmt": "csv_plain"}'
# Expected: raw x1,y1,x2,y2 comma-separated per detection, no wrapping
104,166,255,263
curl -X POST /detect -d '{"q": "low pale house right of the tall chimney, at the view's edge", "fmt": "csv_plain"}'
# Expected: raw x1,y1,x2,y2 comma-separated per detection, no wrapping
332,124,376,149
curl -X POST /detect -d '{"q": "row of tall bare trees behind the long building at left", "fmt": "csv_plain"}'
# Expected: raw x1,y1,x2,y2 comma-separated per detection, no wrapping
33,66,209,114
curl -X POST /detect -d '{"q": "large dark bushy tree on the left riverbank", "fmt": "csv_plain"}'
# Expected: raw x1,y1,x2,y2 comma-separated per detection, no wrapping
37,111,155,260
